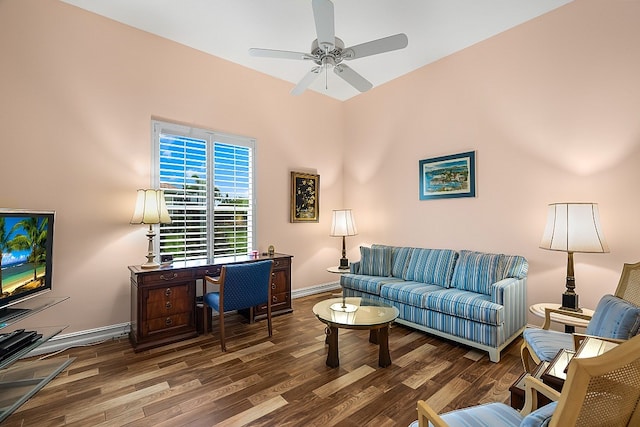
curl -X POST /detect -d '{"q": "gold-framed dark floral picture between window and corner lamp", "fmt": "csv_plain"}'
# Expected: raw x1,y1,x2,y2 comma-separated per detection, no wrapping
291,172,320,222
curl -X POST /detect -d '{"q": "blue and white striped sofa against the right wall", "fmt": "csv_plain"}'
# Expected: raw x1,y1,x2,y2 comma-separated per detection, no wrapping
340,245,529,362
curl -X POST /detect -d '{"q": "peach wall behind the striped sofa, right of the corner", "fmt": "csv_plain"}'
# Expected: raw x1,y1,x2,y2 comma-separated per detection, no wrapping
345,0,640,321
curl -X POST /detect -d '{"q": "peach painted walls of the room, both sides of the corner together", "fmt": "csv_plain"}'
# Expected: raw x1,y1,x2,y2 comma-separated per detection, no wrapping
0,0,640,332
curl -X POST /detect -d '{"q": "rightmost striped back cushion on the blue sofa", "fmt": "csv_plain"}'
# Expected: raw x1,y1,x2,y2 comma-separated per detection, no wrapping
451,251,504,295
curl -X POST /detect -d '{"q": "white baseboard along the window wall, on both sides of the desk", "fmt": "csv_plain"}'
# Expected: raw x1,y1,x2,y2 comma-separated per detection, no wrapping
25,282,340,357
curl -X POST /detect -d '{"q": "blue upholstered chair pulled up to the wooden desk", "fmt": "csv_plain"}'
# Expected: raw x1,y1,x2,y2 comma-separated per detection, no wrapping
202,260,273,351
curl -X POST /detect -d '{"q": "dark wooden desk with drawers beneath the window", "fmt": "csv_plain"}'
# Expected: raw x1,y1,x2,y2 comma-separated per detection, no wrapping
129,254,293,352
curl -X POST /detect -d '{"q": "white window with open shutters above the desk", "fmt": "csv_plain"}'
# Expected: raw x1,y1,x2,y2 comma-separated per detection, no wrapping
152,120,256,261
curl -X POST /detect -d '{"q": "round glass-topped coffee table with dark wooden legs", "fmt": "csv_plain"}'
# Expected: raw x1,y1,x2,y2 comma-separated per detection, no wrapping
313,297,399,368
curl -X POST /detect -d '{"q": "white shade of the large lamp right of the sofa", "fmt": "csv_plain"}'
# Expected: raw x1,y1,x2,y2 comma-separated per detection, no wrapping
540,203,609,253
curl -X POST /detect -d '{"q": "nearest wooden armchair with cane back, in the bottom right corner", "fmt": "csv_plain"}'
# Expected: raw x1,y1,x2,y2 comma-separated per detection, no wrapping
410,336,640,427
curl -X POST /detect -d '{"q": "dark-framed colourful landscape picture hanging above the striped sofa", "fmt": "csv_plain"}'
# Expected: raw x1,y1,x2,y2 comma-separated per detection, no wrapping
418,151,476,200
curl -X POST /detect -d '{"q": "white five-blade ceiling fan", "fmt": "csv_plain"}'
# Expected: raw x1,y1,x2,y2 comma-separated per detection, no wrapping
249,0,409,95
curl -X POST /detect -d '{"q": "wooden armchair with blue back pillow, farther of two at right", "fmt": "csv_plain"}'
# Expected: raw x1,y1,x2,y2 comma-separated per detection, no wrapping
520,262,640,373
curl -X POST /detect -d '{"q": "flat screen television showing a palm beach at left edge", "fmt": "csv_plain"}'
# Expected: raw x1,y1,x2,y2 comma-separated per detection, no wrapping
0,208,55,322
